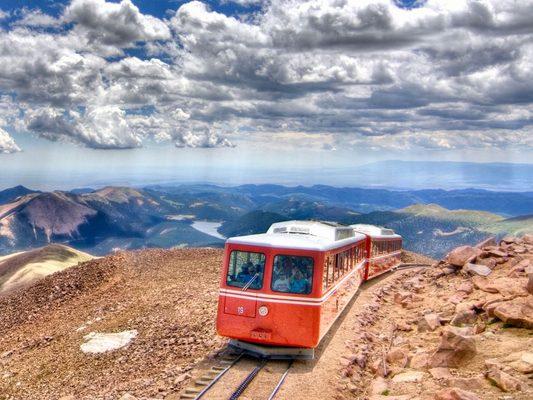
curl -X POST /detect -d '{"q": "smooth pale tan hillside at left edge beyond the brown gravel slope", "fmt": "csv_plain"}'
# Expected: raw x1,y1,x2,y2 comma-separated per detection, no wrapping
0,244,93,295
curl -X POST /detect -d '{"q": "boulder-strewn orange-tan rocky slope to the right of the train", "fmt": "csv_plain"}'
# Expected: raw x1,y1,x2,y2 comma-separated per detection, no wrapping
336,235,533,400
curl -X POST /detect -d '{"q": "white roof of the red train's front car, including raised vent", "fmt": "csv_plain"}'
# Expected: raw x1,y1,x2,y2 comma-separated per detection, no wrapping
226,221,365,251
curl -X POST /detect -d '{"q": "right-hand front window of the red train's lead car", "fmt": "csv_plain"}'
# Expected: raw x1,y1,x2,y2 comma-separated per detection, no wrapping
271,255,314,294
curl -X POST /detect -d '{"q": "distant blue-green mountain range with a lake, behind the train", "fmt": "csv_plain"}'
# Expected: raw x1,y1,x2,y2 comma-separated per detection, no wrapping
0,185,533,256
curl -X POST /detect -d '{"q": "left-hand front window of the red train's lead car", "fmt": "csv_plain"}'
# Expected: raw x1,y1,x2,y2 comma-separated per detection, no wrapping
226,250,265,289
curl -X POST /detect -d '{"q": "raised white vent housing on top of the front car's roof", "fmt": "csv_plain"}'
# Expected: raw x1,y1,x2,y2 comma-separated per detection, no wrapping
267,221,354,240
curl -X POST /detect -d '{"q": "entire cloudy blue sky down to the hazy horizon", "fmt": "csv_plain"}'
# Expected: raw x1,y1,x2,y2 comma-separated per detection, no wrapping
0,0,533,186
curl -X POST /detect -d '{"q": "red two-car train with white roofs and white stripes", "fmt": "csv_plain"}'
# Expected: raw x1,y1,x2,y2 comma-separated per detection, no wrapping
217,221,402,358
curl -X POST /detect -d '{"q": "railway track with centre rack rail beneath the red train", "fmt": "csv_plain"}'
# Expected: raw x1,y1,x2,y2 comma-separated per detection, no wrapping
180,263,430,400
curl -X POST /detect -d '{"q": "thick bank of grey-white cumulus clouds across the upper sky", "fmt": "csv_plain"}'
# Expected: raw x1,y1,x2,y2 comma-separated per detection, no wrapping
0,0,533,150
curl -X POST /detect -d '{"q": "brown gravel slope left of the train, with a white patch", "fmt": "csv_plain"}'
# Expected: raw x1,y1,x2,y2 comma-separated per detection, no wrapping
0,249,224,400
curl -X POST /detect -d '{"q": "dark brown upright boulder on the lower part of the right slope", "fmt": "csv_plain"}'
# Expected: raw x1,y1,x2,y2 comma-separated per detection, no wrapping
428,326,477,368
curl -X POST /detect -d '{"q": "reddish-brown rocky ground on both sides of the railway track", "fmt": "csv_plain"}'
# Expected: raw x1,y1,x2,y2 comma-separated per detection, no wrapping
0,241,533,400
